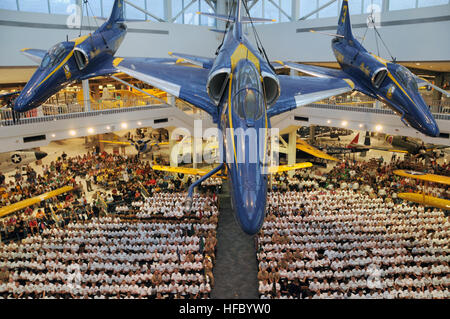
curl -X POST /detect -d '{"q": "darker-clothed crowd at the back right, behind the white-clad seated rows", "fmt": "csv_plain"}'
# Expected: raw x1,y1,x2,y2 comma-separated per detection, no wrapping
272,158,450,202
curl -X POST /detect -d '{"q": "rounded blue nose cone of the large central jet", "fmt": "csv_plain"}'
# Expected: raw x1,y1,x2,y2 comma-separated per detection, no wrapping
237,191,265,235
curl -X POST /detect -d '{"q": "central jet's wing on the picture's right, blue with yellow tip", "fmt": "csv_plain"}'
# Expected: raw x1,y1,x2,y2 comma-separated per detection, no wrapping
267,75,355,117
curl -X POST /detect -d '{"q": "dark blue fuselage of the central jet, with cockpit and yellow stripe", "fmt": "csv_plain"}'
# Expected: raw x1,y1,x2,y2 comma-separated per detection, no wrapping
216,23,270,235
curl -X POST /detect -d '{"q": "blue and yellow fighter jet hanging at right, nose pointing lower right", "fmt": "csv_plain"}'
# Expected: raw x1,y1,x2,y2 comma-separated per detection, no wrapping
285,0,445,137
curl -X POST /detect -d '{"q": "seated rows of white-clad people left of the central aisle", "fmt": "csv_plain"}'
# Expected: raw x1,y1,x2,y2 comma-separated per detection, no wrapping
0,216,217,299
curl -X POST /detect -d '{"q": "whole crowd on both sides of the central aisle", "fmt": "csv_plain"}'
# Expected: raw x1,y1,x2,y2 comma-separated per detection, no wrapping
0,142,450,299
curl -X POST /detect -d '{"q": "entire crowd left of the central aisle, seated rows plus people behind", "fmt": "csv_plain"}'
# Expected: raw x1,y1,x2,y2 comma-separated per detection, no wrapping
0,153,221,299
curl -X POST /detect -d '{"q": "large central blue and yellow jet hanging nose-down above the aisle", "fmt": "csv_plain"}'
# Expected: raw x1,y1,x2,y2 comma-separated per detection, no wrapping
115,0,354,235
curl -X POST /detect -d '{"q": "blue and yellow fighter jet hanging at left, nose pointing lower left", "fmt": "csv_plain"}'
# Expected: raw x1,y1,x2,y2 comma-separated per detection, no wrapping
13,0,127,112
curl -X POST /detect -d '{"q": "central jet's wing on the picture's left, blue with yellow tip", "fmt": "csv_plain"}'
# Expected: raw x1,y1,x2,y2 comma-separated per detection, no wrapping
114,58,218,122
